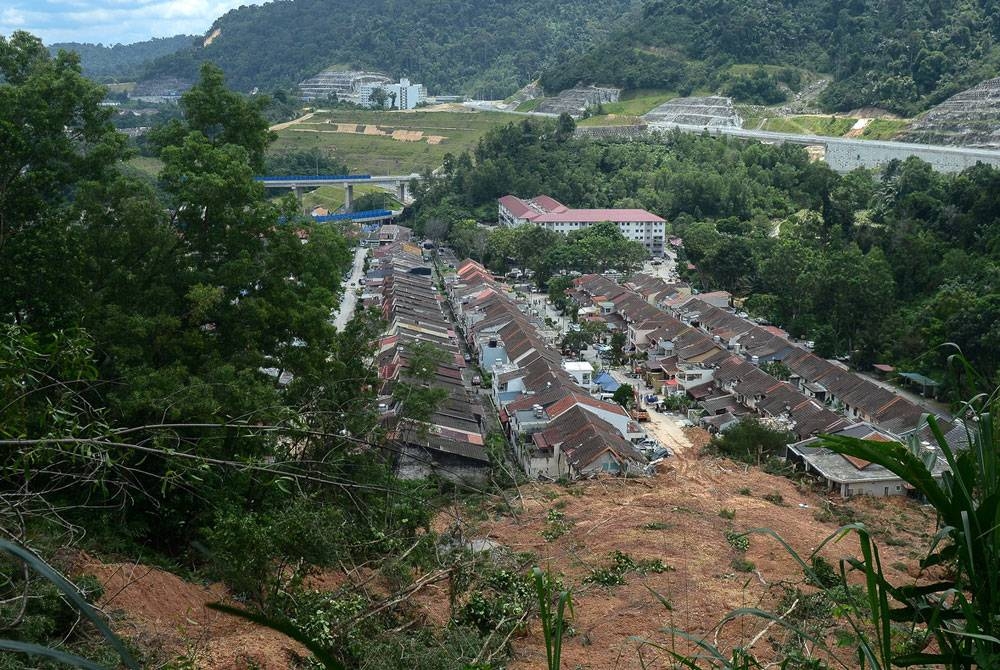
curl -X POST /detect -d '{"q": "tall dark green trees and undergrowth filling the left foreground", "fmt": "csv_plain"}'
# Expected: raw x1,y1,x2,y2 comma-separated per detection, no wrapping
0,32,529,668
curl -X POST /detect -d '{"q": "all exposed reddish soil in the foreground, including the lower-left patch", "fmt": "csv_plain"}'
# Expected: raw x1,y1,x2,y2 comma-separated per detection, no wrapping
84,446,934,670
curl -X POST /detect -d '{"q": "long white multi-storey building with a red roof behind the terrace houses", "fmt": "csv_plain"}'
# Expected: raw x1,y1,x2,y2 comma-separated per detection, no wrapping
499,195,667,256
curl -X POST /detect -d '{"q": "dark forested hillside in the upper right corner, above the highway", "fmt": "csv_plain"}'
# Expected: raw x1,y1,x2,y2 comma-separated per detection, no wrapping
542,0,1000,115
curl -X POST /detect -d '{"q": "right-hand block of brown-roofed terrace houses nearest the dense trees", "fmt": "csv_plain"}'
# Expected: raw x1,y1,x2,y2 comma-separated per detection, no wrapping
570,275,965,495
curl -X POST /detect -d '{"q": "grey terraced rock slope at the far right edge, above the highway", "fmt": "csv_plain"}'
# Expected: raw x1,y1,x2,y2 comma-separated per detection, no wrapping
902,77,1000,149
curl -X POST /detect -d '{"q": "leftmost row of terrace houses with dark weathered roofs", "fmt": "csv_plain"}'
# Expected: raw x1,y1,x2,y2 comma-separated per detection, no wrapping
365,241,490,480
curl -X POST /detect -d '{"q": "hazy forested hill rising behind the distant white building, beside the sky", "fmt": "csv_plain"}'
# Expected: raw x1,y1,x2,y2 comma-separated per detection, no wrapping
140,0,637,97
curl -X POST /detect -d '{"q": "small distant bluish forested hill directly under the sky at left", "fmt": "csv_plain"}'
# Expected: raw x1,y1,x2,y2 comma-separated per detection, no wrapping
48,35,198,81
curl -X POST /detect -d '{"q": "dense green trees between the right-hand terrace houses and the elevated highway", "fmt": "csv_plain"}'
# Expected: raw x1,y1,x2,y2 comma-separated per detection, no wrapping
413,117,1000,392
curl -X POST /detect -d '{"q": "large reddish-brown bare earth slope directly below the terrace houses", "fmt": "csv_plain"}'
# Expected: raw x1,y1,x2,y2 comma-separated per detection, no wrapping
481,444,933,669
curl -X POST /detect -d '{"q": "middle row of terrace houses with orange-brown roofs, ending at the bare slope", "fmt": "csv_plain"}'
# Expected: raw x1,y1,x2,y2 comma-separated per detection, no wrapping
446,261,647,479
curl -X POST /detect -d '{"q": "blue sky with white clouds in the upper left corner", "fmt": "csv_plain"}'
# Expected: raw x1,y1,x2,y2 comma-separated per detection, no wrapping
0,0,263,46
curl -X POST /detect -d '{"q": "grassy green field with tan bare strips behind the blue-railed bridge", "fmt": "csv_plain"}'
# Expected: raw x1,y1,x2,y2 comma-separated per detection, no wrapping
271,110,522,175
